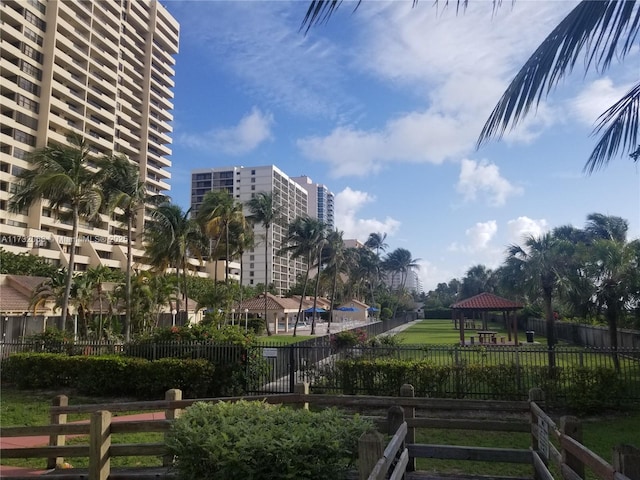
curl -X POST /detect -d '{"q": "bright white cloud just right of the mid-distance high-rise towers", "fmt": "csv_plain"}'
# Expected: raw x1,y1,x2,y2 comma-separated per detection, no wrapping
335,187,400,242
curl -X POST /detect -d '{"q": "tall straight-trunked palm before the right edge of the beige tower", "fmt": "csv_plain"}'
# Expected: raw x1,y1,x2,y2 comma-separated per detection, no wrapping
98,154,168,341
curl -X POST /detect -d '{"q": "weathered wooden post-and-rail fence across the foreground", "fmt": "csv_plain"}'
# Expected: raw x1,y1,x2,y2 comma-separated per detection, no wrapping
0,385,640,480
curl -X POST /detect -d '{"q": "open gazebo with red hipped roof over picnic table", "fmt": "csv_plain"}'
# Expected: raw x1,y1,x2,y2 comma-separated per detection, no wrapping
451,292,522,345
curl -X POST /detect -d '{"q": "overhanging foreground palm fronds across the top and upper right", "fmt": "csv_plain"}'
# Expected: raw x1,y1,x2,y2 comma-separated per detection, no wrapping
302,0,640,173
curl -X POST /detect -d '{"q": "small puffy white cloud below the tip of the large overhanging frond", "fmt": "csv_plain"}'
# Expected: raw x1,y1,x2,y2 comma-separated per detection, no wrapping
456,159,523,206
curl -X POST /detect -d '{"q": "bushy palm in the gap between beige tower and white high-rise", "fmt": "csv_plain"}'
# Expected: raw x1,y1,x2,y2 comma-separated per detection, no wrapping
145,202,205,315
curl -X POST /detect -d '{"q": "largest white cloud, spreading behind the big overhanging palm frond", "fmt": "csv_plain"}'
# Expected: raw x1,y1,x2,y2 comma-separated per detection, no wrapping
298,2,570,178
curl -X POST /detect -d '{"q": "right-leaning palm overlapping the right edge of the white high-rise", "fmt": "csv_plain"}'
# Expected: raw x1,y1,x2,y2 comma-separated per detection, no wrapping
279,216,324,337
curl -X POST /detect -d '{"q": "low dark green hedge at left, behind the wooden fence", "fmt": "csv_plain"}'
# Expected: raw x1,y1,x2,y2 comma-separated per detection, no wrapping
1,353,216,399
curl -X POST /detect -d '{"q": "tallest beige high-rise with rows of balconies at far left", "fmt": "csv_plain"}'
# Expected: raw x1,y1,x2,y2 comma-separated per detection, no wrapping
0,0,179,270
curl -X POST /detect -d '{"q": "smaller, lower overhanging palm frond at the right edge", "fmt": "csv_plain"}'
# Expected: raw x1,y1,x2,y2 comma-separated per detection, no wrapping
584,83,640,173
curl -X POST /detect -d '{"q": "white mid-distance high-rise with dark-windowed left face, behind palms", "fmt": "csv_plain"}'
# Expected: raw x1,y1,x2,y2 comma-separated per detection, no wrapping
191,165,308,295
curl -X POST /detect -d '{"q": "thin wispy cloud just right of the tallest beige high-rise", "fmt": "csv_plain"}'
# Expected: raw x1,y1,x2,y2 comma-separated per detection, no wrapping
179,107,273,155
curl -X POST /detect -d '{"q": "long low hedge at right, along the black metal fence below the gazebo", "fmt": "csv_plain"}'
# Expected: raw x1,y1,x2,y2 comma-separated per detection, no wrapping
312,357,627,413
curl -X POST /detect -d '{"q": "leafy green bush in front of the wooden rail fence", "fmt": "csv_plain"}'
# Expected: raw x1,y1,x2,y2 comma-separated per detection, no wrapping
167,401,373,480
